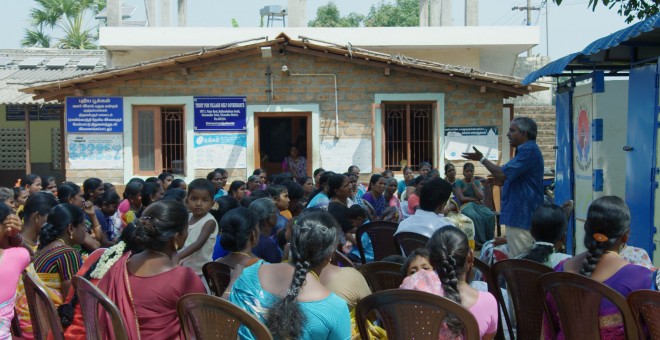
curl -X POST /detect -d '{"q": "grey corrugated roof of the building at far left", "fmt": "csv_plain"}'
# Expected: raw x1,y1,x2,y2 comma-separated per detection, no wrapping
0,48,105,105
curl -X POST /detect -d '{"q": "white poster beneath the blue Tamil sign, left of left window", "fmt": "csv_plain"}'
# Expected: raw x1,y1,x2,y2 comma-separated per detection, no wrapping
66,134,124,169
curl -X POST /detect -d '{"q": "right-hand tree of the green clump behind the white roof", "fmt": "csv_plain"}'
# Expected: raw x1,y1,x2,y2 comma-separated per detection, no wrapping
364,0,419,27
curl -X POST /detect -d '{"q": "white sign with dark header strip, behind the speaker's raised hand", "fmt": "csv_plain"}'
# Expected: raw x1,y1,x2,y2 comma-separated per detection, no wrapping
445,126,499,161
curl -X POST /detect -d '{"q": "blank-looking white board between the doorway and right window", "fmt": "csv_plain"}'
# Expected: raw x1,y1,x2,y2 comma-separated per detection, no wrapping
321,138,372,173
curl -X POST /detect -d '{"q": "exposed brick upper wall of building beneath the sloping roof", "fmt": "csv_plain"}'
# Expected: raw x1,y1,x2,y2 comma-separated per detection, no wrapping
77,53,502,181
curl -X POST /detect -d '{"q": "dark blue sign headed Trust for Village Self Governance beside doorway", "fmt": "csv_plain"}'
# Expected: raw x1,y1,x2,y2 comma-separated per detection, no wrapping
194,97,247,131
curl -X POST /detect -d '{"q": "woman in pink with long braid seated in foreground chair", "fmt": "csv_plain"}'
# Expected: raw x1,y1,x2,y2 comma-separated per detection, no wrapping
401,226,498,339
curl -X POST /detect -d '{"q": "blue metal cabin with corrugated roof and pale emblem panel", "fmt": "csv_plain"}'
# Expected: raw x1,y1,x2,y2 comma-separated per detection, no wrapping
523,14,660,266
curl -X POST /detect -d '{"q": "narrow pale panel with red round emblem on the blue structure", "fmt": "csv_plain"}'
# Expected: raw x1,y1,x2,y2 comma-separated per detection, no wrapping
573,94,593,220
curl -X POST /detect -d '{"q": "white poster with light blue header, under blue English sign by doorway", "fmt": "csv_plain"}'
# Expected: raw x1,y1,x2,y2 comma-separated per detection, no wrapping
194,133,247,169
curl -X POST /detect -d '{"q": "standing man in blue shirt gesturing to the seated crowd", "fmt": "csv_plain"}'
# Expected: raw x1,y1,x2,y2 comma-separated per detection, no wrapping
463,117,543,257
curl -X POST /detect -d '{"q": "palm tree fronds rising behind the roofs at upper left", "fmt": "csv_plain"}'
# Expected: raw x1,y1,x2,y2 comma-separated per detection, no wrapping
21,0,106,49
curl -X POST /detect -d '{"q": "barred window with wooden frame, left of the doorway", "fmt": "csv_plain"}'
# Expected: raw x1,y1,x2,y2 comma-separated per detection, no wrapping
133,106,185,176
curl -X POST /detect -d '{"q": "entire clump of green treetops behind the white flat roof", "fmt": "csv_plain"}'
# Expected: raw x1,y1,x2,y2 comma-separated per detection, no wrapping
307,0,419,27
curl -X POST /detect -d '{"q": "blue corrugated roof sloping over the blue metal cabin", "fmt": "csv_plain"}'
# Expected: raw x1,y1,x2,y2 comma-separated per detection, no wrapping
522,14,660,84
